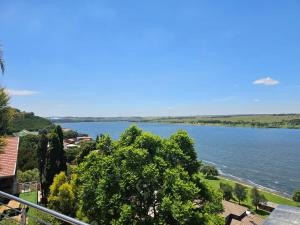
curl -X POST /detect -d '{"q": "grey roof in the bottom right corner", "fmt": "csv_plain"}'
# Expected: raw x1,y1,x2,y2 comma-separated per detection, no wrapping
263,205,300,225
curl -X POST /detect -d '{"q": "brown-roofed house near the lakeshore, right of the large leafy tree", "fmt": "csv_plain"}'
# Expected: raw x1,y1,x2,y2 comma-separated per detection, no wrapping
222,201,263,225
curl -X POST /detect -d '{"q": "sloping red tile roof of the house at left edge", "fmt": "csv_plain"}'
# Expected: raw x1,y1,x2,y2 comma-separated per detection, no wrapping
0,137,19,178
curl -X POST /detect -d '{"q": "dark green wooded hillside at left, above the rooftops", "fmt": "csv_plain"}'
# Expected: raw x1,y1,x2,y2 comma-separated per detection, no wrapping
9,109,52,133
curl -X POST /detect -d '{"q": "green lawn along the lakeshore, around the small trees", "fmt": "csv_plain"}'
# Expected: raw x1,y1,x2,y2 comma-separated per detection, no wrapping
203,176,300,218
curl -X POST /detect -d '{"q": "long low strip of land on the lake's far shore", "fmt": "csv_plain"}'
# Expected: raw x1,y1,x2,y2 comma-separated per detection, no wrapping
51,114,300,129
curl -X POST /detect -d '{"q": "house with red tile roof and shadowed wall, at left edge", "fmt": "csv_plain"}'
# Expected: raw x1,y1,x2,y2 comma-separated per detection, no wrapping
0,137,19,195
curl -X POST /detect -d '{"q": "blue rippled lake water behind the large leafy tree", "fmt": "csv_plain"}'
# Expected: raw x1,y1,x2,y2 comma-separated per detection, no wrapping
61,122,300,195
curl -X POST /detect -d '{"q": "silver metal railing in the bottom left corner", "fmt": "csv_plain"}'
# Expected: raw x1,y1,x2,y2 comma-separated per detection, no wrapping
0,191,88,225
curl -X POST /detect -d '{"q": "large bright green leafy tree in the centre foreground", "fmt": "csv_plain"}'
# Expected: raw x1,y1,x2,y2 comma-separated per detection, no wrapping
77,126,224,225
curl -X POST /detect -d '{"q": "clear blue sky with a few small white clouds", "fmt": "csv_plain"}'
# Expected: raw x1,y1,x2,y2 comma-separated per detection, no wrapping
0,0,300,116
